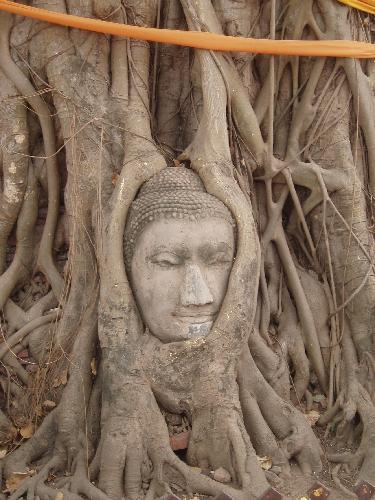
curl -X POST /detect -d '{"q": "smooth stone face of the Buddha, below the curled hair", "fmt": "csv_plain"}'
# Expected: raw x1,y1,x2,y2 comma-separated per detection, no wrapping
131,217,235,343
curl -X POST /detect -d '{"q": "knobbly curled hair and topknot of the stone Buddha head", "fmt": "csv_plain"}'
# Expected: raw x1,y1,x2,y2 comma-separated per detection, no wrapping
124,167,235,267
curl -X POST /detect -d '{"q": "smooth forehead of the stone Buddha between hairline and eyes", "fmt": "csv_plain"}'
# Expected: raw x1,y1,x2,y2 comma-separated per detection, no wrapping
136,217,234,254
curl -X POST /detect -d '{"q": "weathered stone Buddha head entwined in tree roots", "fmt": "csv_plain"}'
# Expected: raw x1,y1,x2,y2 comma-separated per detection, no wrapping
124,167,235,343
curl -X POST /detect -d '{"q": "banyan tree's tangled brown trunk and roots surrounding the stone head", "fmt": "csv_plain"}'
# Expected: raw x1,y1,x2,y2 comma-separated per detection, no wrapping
0,0,375,500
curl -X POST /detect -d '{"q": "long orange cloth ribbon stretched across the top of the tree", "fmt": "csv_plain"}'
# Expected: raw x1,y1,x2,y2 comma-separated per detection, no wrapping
0,0,375,59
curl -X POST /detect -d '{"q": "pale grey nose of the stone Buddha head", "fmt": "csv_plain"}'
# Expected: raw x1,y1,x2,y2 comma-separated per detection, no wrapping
180,264,214,306
